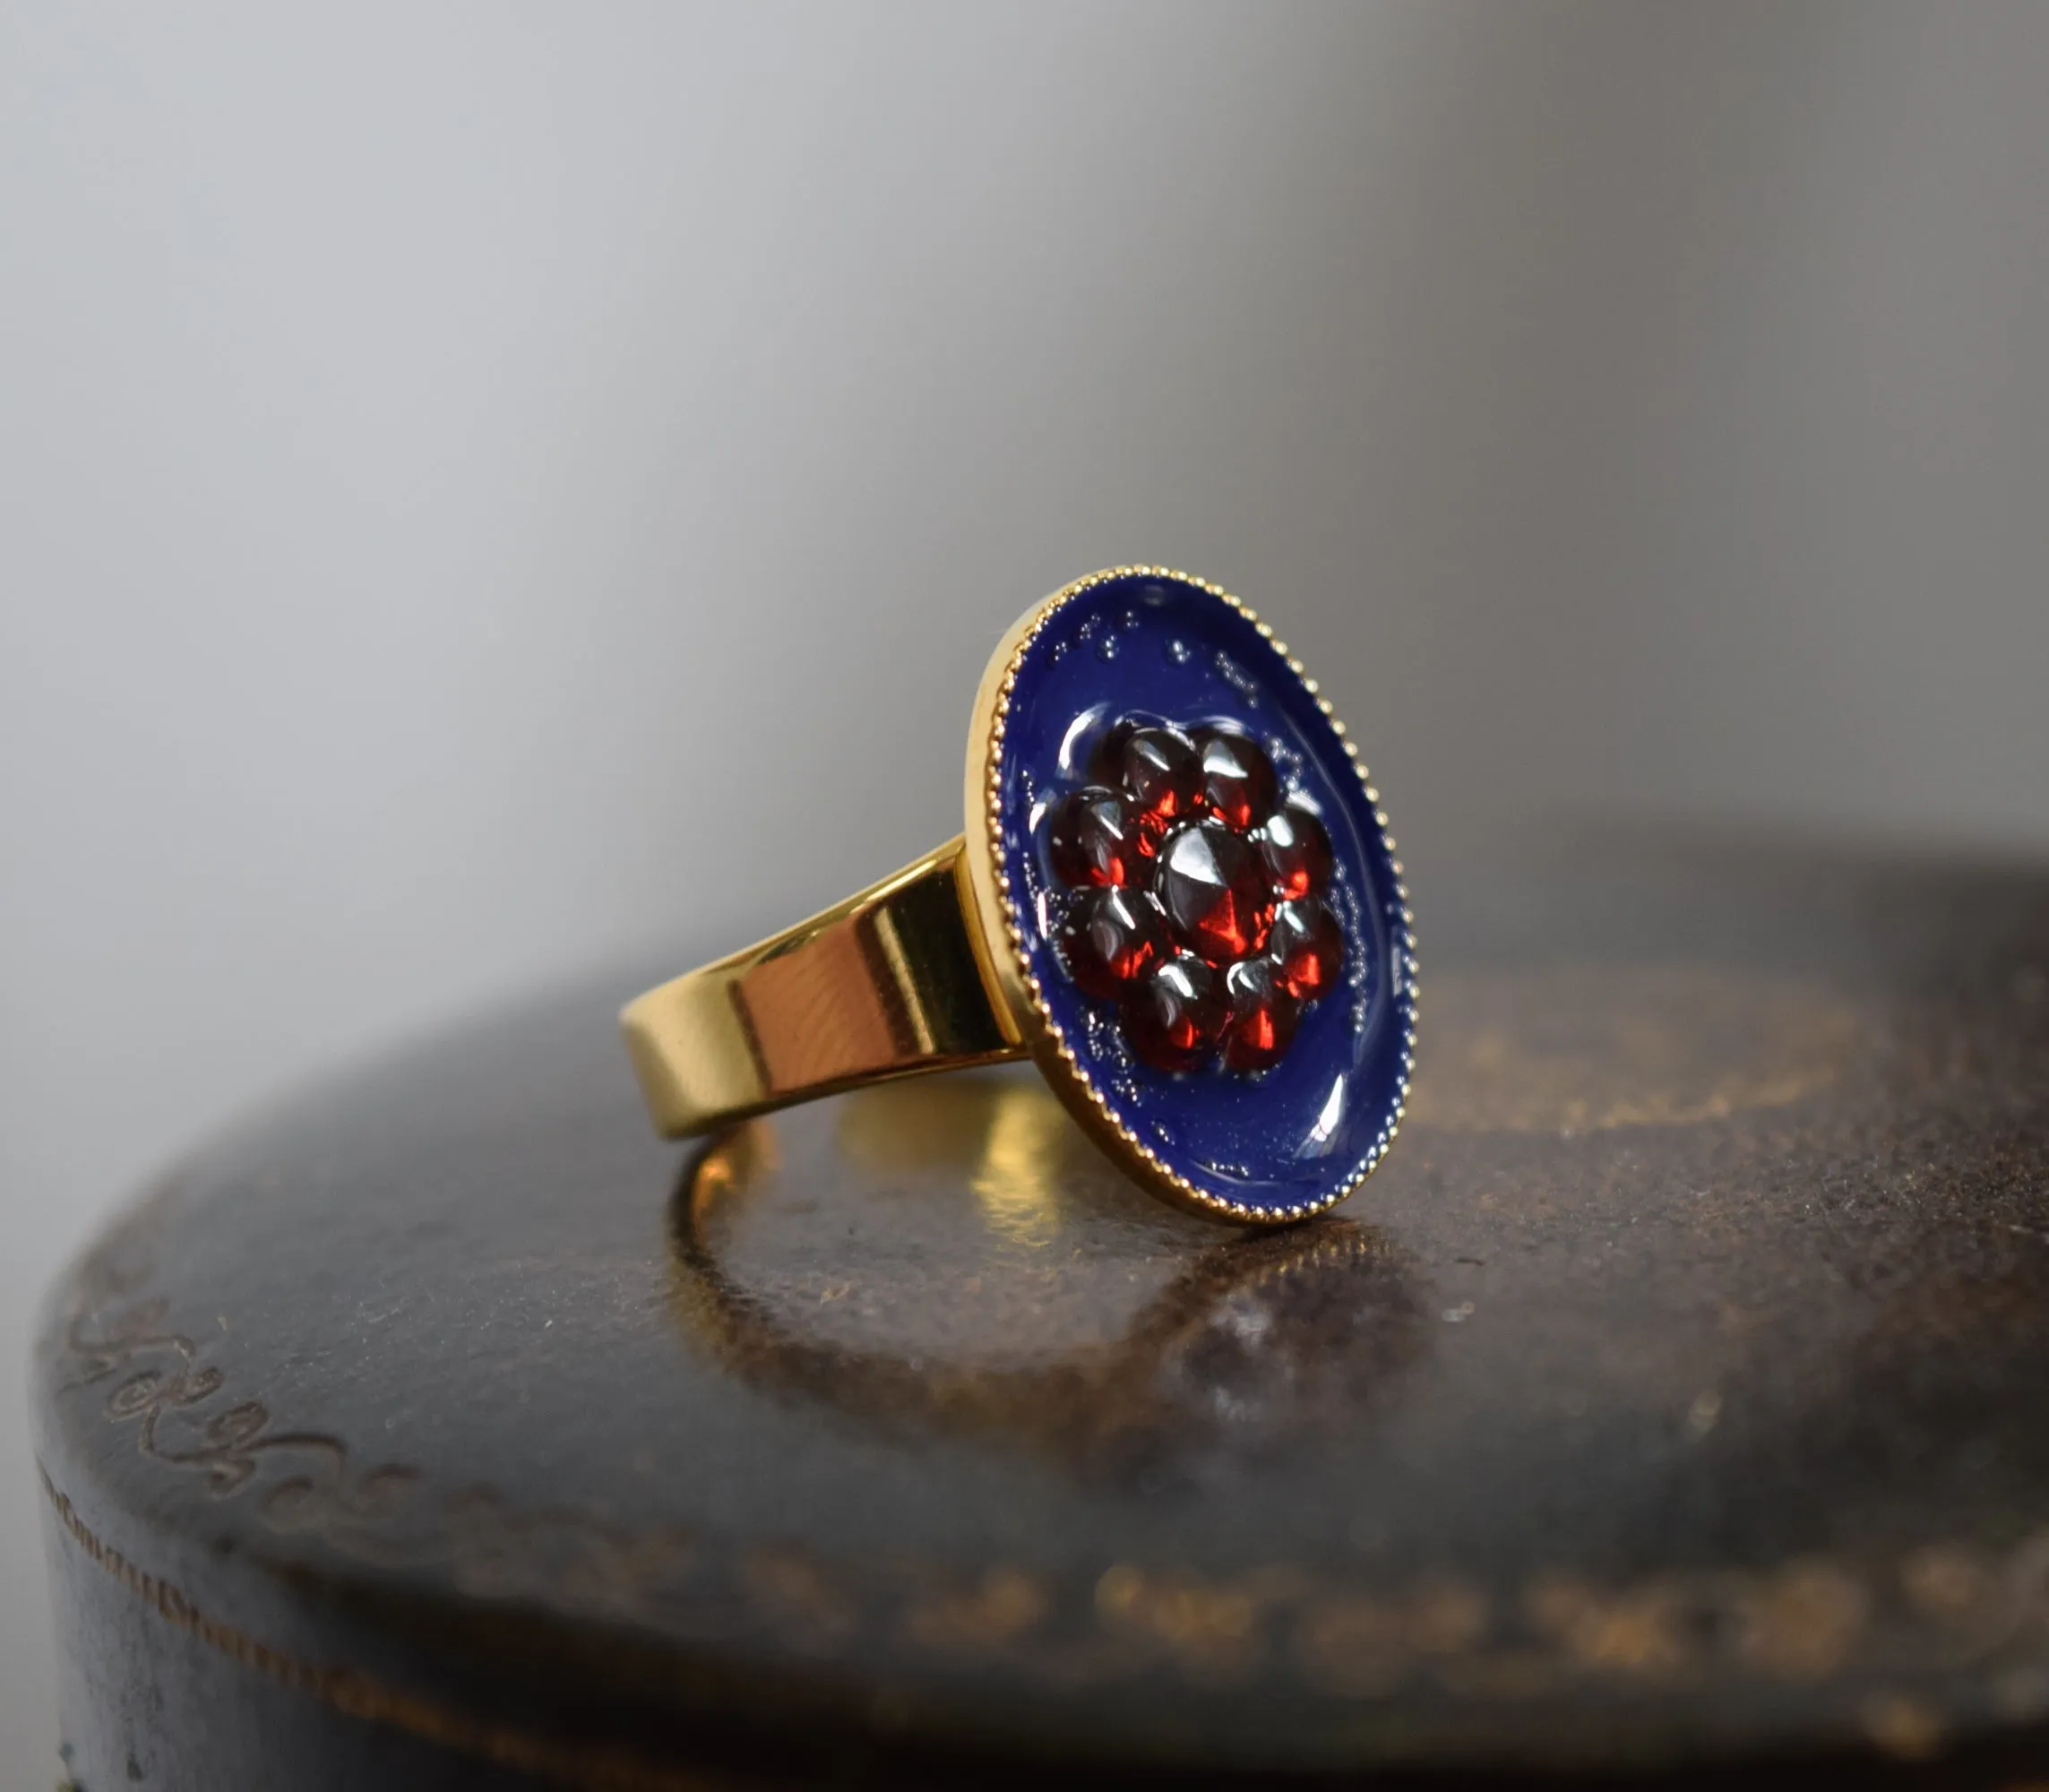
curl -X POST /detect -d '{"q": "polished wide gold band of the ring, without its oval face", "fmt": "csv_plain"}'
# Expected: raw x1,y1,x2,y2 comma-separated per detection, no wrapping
619,838,1025,1139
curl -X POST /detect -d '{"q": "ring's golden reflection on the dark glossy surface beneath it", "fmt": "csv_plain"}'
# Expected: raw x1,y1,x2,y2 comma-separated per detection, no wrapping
672,1071,1426,1475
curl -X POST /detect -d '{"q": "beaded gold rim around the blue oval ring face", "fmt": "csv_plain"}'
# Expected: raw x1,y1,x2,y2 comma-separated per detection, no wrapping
961,565,1418,1225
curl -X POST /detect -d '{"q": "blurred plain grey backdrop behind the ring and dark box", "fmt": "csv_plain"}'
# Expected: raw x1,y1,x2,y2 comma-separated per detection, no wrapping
0,0,2049,1788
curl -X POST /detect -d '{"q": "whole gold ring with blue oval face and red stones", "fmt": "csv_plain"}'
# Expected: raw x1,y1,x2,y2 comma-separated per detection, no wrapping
621,565,1416,1225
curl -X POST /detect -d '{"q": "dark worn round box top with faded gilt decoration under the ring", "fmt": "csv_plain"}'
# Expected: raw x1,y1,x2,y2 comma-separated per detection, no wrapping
37,844,2049,1792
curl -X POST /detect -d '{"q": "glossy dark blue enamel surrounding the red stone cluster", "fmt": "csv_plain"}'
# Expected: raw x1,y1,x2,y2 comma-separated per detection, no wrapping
1000,575,1412,1212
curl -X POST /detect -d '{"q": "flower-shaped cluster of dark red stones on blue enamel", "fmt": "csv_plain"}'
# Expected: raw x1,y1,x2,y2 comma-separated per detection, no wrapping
1047,719,1344,1071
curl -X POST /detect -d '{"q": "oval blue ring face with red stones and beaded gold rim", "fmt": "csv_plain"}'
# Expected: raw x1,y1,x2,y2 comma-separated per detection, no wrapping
969,567,1416,1223
